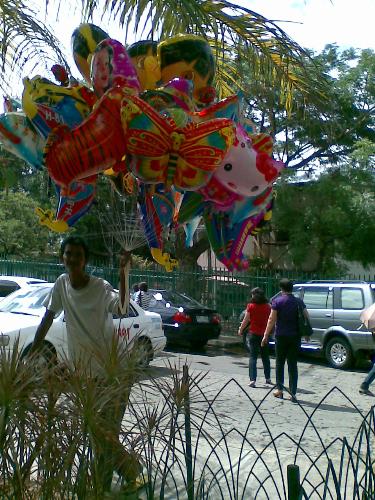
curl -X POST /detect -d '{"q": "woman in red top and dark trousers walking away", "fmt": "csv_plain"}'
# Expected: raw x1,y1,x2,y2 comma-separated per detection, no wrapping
238,288,272,387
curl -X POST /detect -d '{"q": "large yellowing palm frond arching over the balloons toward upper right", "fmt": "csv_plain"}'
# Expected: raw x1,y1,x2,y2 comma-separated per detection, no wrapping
83,0,328,111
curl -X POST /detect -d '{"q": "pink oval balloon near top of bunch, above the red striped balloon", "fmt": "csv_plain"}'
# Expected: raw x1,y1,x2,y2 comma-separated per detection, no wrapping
91,38,141,97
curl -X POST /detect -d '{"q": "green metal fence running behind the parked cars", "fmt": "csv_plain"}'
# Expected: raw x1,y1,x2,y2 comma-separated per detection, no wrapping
0,259,375,334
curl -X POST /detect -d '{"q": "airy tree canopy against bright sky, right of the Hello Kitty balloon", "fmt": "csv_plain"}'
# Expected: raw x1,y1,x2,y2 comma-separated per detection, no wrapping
247,45,375,171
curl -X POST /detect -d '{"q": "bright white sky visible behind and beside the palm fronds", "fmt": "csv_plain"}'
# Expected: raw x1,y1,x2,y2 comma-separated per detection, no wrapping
3,0,375,95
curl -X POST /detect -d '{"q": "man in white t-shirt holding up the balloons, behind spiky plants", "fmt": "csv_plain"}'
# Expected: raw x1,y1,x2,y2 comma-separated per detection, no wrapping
30,236,140,488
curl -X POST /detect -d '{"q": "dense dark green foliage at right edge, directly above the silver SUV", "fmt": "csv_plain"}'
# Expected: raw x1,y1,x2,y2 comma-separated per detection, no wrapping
272,145,375,273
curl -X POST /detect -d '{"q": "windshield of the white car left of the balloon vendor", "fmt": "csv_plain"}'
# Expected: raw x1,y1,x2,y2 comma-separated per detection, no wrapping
0,286,51,316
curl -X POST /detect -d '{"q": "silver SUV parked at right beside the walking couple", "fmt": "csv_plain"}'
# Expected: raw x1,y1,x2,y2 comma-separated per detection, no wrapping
241,280,375,369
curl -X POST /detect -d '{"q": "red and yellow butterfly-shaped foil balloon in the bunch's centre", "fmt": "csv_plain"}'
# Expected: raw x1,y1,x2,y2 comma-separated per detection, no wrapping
121,96,235,190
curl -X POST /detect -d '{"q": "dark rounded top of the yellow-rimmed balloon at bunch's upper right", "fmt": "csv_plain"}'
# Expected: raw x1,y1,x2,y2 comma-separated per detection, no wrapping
158,35,215,85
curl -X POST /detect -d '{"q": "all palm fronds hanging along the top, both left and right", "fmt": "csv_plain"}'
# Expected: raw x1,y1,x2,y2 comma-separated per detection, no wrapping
0,0,324,110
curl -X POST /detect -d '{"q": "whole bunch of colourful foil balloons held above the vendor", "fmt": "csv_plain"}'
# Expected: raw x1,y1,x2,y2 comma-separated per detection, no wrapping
0,24,284,271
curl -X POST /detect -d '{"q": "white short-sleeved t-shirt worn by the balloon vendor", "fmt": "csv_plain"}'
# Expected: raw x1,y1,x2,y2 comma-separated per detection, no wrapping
43,274,120,375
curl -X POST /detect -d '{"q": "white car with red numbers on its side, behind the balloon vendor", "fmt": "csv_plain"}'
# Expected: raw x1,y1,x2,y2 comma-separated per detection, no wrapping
0,282,166,367
